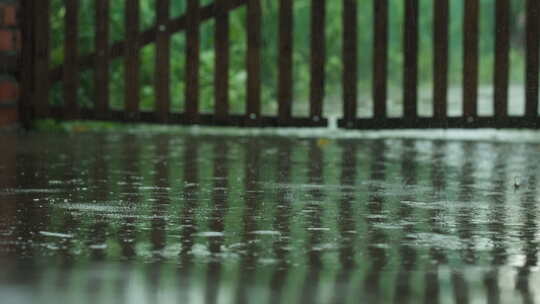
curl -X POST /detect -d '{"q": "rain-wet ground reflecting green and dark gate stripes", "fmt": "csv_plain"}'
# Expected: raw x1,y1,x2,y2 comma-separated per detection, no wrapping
0,134,540,303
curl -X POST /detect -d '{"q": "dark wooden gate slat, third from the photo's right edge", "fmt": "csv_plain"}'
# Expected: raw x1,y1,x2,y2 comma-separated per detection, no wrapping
463,0,480,117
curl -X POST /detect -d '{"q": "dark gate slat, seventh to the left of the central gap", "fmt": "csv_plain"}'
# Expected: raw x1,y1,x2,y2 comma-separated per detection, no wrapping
124,0,140,119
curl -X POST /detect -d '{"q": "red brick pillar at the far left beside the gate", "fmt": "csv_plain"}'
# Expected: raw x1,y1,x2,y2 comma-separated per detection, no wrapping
0,0,21,127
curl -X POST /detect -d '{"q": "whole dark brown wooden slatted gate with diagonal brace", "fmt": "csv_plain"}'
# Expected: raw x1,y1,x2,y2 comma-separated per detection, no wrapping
21,0,540,129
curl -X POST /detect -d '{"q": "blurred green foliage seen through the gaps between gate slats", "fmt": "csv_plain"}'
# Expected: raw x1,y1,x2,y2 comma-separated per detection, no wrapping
51,0,524,113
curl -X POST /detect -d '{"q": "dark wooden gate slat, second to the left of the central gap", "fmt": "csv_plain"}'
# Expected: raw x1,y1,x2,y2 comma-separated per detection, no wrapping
278,0,294,124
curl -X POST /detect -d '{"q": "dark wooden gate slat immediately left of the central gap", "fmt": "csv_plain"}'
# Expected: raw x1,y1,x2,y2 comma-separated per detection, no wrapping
309,0,326,122
